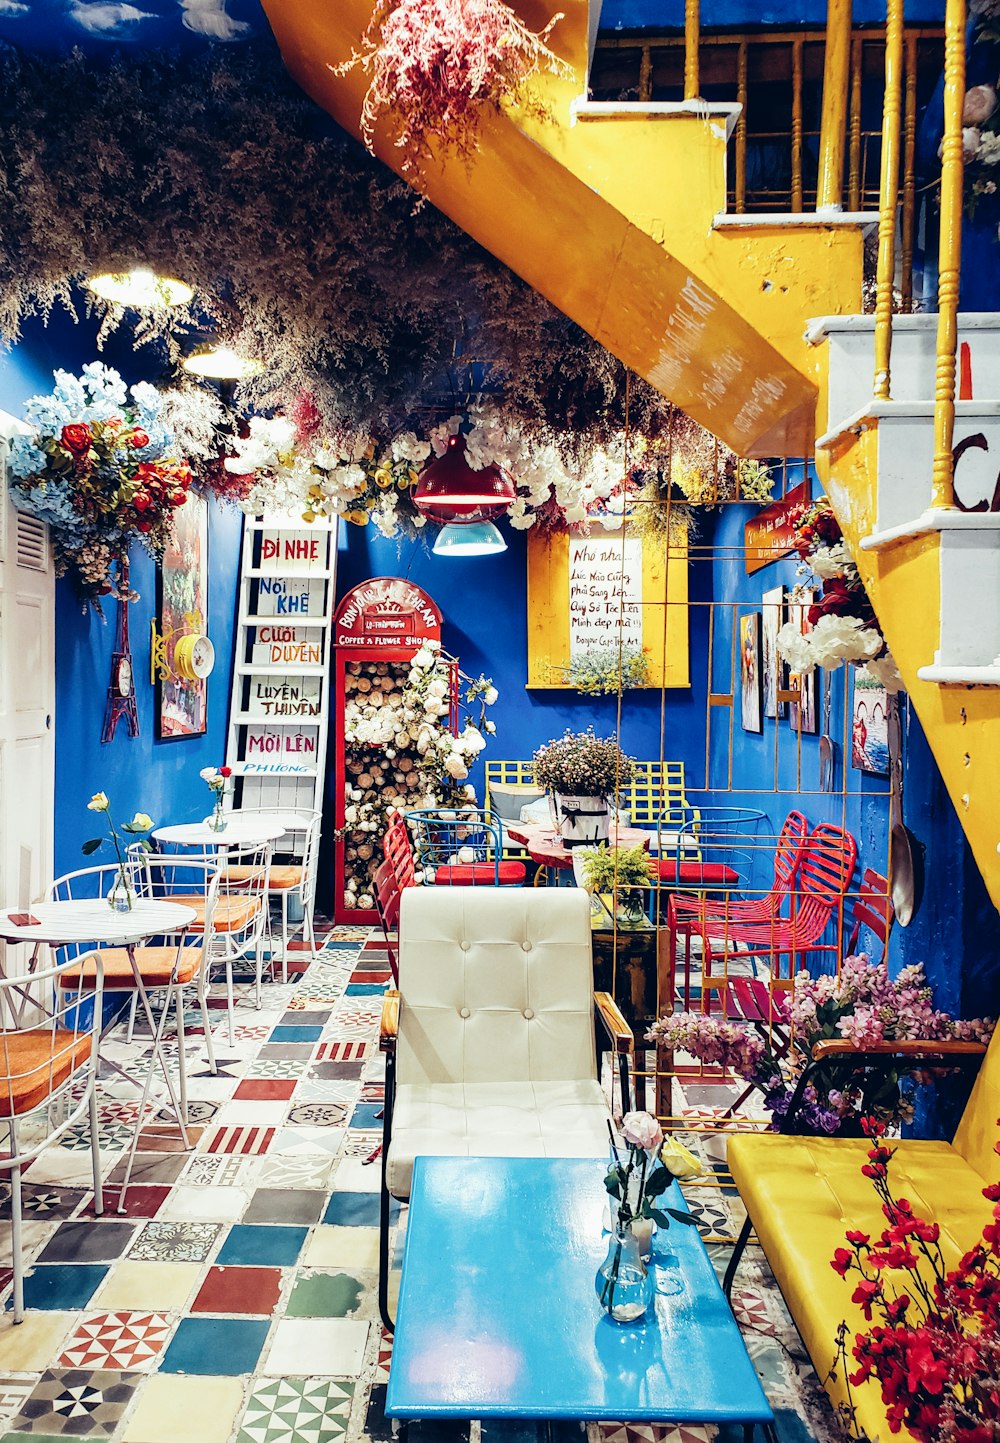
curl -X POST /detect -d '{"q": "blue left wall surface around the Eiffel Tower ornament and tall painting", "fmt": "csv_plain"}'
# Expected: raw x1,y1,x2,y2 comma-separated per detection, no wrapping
0,316,241,874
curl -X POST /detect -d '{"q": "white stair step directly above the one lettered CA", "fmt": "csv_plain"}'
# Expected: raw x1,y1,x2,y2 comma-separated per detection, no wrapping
805,312,1000,434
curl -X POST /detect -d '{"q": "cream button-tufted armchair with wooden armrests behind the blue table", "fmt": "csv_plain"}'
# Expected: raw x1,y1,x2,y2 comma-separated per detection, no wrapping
380,887,633,1329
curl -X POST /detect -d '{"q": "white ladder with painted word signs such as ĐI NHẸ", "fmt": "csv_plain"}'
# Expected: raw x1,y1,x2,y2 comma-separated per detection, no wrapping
225,512,336,811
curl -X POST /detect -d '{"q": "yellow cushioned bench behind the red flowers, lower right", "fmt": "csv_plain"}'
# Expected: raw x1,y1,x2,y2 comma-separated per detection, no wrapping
726,1029,1000,1443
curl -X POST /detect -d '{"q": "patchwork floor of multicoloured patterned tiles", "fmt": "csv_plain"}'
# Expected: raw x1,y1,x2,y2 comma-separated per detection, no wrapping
0,923,840,1443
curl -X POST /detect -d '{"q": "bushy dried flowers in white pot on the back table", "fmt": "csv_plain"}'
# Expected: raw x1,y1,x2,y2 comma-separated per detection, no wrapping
534,727,635,847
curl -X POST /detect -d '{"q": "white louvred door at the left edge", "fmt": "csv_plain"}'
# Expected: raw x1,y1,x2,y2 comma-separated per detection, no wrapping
0,411,55,906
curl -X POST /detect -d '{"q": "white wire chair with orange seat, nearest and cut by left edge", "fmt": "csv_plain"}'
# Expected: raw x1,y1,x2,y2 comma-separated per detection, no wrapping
0,957,104,1323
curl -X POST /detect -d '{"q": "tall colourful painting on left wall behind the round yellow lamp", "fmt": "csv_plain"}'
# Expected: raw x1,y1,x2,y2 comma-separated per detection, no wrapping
156,491,208,742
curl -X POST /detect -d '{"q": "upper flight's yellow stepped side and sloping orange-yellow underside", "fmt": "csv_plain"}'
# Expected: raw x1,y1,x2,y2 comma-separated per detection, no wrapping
264,0,861,456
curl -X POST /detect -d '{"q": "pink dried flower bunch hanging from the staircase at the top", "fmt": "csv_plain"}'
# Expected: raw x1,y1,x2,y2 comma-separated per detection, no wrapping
335,0,571,172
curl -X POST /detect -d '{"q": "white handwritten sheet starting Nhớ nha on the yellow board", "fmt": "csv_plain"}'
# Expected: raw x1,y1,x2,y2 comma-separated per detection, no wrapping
570,535,642,661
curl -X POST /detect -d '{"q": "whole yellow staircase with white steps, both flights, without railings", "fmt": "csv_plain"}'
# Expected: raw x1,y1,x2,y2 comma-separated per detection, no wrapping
263,0,1000,906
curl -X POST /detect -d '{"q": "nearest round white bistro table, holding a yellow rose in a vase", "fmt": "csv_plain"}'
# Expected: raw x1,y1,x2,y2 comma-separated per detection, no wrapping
0,898,198,1212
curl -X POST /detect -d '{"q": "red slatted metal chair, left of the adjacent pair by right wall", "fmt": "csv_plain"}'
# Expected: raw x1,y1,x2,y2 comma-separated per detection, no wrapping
667,811,810,1022
